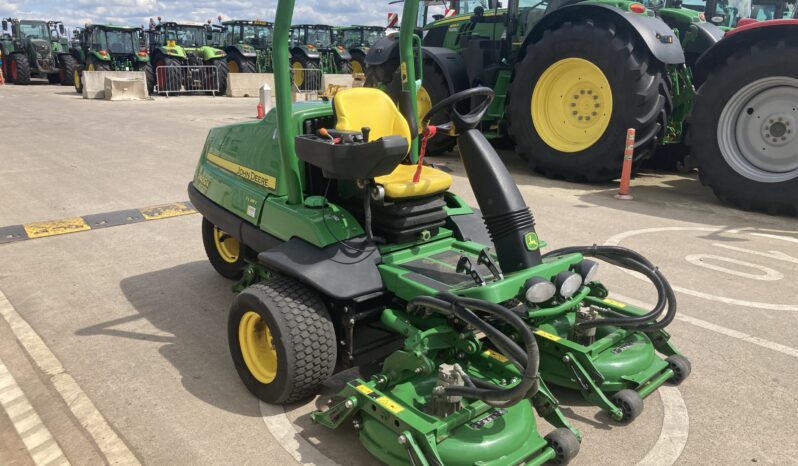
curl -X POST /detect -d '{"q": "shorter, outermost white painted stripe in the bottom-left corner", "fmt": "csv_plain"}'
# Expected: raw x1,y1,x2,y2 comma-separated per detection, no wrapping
0,359,69,466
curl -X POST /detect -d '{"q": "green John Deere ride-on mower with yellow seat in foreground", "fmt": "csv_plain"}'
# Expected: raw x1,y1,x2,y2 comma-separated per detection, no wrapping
188,0,690,466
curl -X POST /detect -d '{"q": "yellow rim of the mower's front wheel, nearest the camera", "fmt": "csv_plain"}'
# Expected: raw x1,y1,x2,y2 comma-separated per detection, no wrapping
238,311,277,383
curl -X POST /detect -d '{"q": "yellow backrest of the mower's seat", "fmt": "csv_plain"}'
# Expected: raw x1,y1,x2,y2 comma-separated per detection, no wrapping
333,87,411,150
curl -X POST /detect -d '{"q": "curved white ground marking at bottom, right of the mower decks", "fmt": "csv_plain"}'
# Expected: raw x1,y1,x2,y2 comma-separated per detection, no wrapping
637,385,690,466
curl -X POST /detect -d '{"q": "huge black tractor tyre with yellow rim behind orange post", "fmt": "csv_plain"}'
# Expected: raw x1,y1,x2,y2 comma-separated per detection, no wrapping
509,20,668,182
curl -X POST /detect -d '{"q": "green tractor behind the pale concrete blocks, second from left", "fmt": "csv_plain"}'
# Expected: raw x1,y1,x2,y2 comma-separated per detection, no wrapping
70,24,155,93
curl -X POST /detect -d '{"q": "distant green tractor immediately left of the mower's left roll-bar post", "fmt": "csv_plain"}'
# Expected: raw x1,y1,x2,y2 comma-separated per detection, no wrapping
216,19,274,73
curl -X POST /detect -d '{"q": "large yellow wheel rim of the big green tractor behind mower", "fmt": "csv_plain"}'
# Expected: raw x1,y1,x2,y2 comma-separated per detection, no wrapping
532,58,612,152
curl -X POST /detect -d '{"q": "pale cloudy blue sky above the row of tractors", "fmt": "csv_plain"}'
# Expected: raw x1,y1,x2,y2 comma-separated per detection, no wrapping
0,0,402,27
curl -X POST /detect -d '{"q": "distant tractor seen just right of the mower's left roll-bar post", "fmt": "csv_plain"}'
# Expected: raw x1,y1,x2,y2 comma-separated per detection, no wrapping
289,24,352,90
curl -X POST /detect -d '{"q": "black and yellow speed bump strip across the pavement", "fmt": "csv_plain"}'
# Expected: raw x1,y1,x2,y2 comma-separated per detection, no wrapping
0,201,197,244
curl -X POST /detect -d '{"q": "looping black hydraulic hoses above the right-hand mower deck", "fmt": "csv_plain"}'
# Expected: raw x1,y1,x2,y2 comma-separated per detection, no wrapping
543,245,676,332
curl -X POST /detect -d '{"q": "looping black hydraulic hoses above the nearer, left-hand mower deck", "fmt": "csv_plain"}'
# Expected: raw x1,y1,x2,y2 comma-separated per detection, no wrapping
408,293,540,407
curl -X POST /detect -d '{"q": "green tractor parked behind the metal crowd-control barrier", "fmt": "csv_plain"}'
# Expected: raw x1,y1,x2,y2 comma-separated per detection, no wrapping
147,16,229,94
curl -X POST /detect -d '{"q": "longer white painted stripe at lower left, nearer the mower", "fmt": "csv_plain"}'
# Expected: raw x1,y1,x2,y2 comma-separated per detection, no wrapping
0,291,141,465
